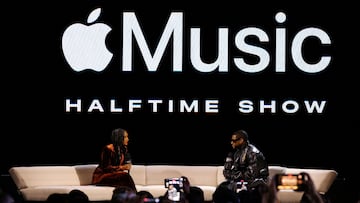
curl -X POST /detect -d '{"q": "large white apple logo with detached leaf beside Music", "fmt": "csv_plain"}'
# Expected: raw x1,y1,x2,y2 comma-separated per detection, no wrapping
62,8,113,72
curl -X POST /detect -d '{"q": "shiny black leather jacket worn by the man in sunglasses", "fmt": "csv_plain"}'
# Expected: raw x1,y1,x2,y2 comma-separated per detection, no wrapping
223,143,269,186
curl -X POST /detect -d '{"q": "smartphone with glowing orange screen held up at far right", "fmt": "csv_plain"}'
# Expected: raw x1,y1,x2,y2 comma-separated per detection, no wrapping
275,174,305,191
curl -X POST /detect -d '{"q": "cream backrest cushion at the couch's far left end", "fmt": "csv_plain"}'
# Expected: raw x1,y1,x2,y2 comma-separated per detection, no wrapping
9,166,80,189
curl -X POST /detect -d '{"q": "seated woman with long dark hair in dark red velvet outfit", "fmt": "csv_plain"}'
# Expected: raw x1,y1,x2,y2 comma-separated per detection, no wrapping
92,128,136,191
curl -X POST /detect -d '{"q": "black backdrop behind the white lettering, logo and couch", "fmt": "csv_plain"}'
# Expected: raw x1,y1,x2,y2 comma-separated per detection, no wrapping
0,1,359,201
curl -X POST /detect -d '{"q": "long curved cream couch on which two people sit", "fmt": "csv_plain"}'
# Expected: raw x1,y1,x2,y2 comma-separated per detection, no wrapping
9,164,337,203
